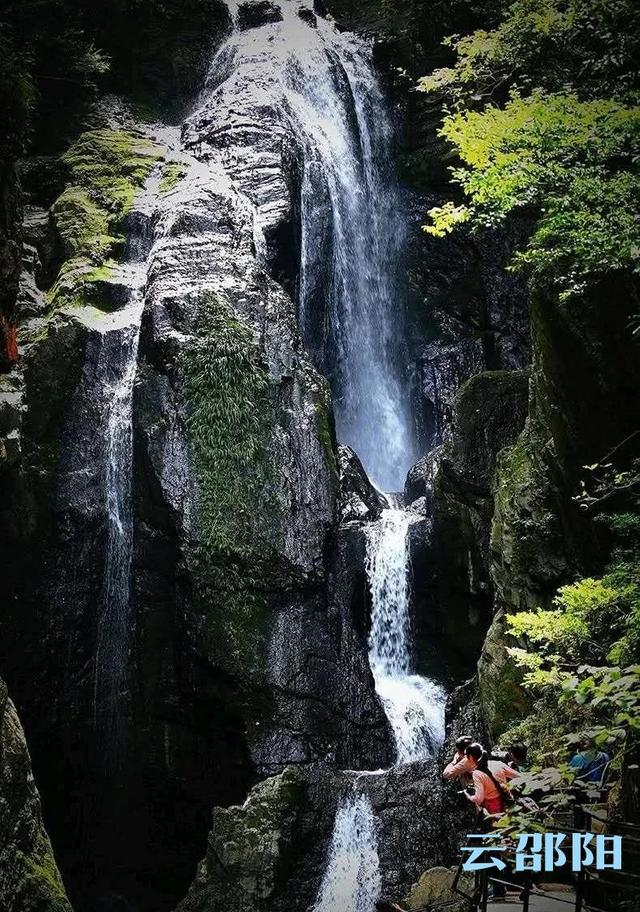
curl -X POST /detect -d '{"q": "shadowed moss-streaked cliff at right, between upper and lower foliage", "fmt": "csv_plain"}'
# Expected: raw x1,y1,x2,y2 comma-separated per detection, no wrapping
479,277,640,731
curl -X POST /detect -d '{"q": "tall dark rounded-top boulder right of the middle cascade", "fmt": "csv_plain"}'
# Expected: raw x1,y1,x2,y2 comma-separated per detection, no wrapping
419,371,528,671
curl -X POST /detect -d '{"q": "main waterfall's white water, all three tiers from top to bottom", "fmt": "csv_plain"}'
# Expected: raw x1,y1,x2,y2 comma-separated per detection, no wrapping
202,0,443,912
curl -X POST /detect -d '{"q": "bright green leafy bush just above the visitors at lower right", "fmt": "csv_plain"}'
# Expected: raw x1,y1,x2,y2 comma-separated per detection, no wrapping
505,560,640,765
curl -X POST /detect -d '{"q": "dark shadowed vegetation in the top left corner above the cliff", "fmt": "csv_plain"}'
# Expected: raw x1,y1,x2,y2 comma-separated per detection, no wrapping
0,0,225,160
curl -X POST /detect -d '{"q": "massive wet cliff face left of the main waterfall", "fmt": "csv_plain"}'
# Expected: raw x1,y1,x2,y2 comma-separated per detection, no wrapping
0,41,389,909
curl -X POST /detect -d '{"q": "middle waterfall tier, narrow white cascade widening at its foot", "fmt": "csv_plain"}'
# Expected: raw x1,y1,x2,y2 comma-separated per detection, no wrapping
367,509,445,764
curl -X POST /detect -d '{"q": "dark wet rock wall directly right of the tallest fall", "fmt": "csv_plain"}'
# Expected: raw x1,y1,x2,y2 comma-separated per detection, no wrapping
410,207,530,446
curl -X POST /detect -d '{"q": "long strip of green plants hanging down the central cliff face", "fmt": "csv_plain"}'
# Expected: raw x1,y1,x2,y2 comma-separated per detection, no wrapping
182,293,281,671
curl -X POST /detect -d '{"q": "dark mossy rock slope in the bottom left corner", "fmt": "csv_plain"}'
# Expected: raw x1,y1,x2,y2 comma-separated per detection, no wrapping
0,680,71,912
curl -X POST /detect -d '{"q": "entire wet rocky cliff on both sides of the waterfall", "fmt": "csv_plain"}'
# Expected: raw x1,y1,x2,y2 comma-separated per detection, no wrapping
7,3,638,912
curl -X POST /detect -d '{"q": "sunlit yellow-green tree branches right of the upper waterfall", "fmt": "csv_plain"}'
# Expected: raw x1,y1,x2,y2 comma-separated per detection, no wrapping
427,91,640,295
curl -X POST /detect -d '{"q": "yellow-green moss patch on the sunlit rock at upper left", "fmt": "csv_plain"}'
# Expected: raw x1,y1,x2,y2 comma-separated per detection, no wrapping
49,130,162,308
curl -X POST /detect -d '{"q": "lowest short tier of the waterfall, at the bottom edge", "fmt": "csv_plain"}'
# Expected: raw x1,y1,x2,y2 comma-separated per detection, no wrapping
313,794,382,912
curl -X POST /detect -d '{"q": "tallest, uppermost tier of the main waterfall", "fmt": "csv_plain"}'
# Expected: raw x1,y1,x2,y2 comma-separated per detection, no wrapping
204,0,416,491
